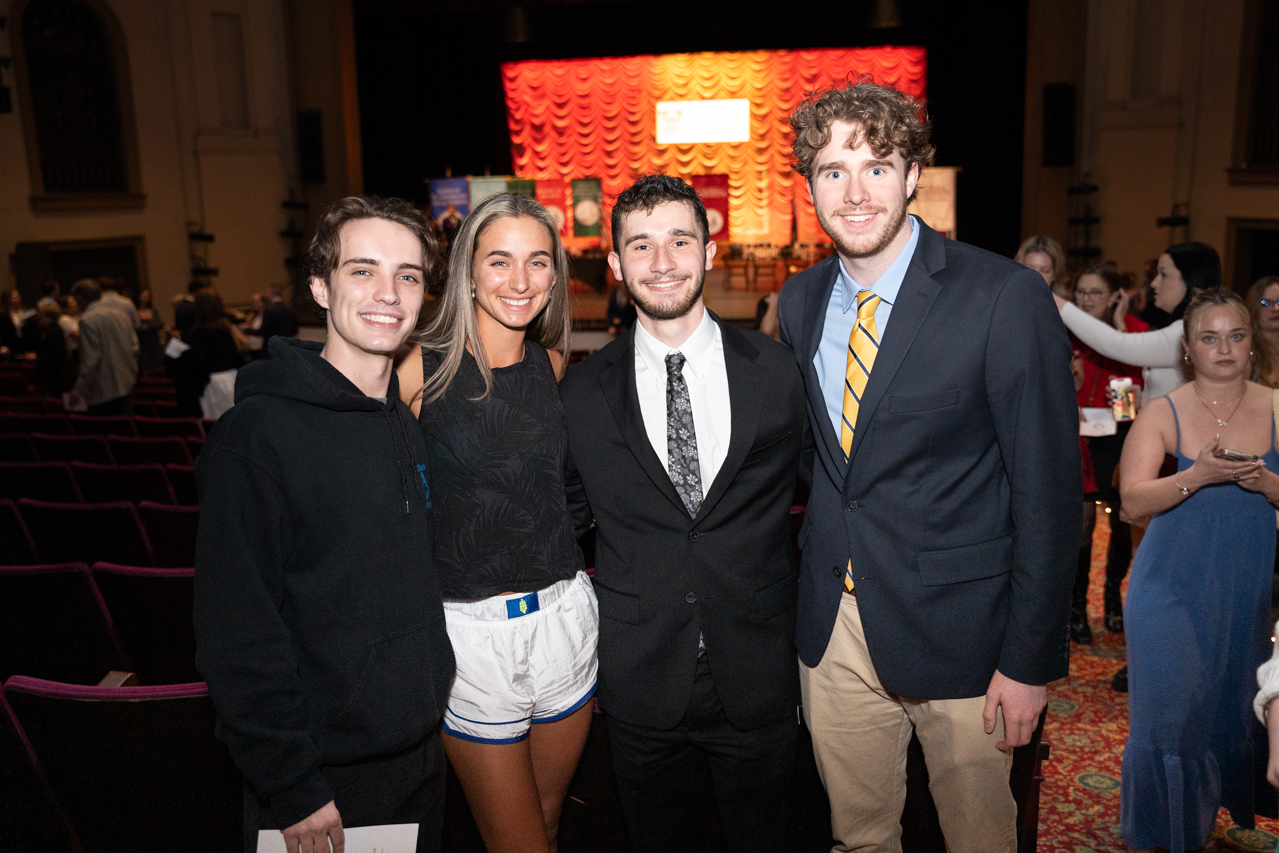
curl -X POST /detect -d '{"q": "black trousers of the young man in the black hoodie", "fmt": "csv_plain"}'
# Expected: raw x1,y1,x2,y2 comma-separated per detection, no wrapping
244,729,445,853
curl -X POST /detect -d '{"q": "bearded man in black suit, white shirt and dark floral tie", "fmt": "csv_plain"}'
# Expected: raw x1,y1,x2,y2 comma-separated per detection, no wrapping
560,175,811,853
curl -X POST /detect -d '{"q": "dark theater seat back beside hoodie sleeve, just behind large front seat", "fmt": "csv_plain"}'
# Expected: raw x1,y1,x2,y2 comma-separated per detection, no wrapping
93,563,200,684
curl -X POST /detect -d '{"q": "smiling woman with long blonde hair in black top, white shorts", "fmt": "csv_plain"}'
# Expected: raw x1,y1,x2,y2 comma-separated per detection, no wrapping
396,193,599,853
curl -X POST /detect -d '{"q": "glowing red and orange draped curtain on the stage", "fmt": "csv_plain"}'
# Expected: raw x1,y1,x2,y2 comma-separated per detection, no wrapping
501,47,926,244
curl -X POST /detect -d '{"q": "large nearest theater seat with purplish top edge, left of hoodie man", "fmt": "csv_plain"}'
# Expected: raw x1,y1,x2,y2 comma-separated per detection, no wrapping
4,675,244,853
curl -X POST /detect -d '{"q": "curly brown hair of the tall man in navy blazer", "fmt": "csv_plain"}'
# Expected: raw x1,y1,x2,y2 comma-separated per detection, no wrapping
790,77,936,193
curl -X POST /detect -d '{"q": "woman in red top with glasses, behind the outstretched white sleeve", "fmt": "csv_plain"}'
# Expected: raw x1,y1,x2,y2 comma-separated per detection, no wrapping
1071,263,1149,645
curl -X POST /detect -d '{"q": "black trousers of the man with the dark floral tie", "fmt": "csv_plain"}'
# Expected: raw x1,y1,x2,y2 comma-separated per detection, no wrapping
609,656,798,853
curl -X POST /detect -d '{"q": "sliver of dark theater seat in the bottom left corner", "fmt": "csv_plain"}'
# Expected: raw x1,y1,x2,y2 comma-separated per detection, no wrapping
0,687,82,853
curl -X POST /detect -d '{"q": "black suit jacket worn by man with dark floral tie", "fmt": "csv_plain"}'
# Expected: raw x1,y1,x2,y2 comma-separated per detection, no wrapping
560,315,807,730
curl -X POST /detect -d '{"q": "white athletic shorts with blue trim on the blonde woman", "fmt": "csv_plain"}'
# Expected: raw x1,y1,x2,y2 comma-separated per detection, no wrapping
444,572,600,743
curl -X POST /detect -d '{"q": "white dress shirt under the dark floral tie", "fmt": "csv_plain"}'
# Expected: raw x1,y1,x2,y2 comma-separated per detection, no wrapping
634,309,733,497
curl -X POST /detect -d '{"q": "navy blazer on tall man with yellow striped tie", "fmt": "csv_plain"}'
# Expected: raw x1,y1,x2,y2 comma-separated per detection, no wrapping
779,223,1083,700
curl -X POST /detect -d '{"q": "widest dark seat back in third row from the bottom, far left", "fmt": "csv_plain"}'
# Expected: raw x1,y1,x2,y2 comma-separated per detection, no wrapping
18,499,154,565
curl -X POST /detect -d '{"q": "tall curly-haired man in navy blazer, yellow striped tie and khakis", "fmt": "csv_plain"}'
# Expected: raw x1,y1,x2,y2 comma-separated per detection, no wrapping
779,82,1082,853
